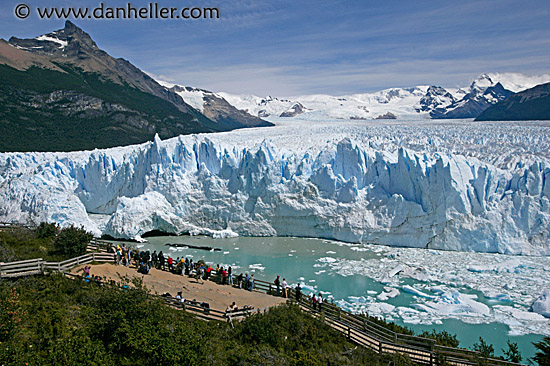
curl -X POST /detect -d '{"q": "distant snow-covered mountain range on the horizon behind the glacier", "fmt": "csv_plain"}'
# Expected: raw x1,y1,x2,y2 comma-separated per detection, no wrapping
217,73,550,119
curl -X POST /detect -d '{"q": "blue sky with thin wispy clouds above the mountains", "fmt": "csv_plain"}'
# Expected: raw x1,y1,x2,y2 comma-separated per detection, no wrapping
0,0,550,96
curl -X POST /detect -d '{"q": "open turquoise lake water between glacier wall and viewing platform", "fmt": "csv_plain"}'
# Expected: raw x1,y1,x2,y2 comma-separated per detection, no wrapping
122,236,543,362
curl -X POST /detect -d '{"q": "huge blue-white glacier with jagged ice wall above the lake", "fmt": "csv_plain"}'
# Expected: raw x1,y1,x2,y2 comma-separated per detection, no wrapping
0,119,550,255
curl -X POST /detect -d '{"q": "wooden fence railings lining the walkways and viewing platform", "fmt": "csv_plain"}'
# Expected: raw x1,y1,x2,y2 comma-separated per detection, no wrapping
0,240,520,366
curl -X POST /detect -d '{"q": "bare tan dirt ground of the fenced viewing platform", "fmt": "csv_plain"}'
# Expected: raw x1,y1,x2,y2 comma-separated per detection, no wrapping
71,263,286,311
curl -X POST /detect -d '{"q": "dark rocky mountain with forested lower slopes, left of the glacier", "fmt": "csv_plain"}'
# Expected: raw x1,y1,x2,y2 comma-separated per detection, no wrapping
0,21,272,151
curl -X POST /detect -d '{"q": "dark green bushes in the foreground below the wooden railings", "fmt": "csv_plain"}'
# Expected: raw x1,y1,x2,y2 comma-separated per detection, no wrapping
0,274,409,365
